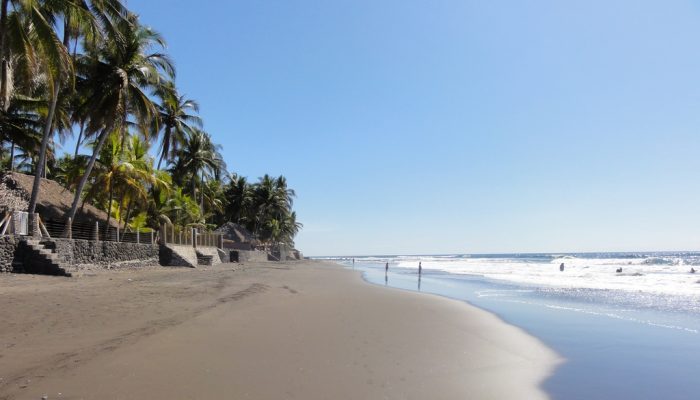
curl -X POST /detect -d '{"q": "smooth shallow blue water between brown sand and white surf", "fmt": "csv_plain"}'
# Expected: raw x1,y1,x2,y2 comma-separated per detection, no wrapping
356,263,700,400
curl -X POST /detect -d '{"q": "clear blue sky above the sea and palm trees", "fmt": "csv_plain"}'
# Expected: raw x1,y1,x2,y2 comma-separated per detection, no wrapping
128,0,700,256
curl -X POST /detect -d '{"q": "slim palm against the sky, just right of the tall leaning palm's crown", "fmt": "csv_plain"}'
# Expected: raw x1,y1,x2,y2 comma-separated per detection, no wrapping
154,82,202,169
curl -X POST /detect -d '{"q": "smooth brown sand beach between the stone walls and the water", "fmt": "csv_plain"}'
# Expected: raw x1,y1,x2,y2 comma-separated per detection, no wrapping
0,261,558,399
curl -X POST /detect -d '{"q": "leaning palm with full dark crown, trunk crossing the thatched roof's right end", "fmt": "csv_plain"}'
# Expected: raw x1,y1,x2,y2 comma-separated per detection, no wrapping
67,14,175,223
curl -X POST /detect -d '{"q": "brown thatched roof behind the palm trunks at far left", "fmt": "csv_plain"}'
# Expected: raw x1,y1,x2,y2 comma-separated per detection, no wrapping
0,172,117,226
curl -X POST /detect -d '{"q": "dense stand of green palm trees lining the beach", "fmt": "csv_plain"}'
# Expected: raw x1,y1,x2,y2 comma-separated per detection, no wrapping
0,0,301,244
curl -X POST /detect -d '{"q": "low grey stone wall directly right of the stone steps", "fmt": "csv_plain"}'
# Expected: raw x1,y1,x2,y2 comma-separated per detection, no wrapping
47,239,159,269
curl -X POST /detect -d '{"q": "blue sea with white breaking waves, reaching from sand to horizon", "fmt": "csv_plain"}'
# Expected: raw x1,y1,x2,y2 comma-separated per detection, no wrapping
326,252,700,399
